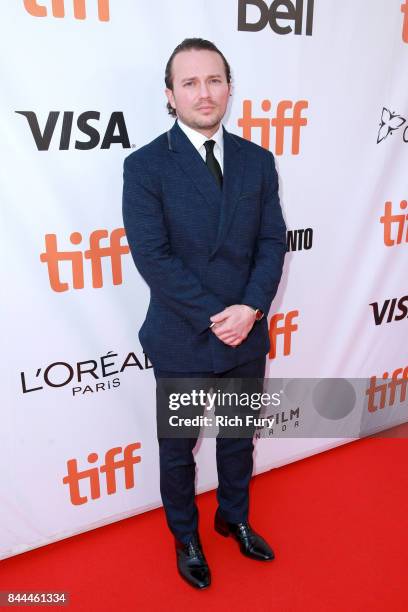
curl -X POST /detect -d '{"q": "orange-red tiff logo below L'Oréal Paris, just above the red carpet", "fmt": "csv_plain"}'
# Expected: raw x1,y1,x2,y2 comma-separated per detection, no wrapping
62,442,141,506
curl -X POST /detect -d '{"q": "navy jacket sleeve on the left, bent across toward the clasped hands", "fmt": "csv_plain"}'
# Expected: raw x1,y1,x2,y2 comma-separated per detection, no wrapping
122,156,226,333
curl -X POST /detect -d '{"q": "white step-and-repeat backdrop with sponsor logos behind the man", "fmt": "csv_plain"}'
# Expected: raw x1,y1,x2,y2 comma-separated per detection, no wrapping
0,0,408,558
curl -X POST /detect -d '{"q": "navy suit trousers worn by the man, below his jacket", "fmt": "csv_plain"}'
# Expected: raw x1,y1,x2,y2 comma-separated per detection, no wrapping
153,356,266,544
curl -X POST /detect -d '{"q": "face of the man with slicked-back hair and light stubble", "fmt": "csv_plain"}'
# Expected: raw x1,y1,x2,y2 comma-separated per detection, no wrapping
165,49,231,136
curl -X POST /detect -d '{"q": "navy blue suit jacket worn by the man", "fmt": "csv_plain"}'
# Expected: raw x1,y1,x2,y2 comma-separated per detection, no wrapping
123,121,286,372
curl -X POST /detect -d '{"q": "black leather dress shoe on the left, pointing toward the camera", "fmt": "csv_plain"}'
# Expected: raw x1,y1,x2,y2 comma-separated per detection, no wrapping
176,532,211,589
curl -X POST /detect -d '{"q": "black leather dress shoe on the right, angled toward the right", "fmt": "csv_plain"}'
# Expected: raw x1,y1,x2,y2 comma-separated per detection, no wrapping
214,510,275,561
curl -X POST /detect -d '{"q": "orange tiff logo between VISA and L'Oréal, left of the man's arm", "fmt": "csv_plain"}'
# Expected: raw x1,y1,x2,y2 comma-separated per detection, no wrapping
40,227,129,292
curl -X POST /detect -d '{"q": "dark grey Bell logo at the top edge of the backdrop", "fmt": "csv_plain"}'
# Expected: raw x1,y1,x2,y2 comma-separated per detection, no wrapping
238,0,314,36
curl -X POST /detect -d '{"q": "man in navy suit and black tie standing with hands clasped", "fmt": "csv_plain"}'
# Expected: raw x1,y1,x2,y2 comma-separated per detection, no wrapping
123,38,286,588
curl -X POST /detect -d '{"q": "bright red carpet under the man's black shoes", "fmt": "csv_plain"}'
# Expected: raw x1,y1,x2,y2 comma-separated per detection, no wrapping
0,438,408,612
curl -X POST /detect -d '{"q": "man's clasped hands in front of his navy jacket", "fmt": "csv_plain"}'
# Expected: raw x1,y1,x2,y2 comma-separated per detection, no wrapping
210,304,255,346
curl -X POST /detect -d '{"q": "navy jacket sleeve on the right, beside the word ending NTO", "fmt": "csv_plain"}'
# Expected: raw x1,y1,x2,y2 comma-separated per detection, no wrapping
241,151,287,316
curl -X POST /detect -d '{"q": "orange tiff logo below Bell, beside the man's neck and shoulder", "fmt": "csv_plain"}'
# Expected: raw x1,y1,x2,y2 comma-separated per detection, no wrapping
238,100,308,155
